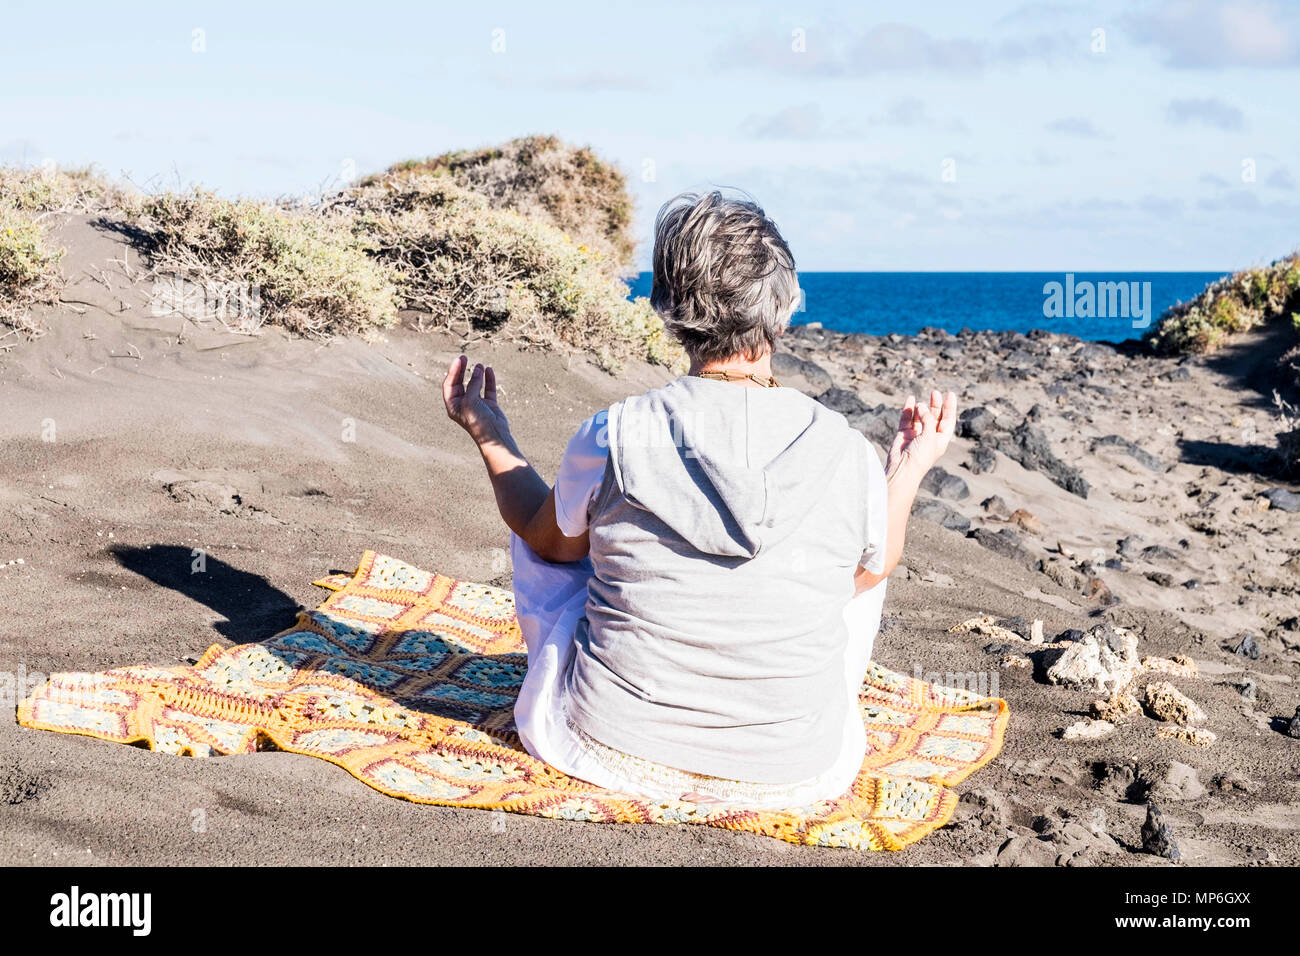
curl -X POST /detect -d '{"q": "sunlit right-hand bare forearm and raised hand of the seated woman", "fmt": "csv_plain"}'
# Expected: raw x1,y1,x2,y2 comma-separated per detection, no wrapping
853,392,957,594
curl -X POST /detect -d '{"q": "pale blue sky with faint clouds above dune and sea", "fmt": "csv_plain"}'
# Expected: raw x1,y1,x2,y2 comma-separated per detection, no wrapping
0,0,1300,271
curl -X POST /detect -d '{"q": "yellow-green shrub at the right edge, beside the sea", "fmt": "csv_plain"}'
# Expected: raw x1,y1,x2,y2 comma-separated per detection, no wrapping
1147,254,1300,355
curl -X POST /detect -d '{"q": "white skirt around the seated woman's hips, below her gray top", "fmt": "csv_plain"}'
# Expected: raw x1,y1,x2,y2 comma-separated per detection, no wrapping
510,533,885,809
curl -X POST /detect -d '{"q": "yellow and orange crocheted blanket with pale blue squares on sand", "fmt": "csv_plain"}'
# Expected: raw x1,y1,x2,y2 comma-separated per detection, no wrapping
18,551,1008,849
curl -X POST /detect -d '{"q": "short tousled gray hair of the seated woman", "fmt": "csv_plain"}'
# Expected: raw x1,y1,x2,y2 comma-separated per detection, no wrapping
650,190,800,362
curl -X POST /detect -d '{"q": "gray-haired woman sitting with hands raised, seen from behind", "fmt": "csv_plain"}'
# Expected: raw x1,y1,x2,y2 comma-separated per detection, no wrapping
443,191,957,808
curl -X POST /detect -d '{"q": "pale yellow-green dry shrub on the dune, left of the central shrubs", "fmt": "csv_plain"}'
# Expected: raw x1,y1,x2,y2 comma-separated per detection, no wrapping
134,190,397,336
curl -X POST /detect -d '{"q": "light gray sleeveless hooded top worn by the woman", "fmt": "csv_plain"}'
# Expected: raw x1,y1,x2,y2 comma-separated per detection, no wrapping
567,377,885,783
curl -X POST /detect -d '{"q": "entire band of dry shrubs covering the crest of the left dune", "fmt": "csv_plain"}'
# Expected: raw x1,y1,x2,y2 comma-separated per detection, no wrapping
0,137,685,369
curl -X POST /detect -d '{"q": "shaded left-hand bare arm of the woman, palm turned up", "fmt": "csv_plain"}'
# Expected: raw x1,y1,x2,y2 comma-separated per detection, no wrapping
442,355,588,562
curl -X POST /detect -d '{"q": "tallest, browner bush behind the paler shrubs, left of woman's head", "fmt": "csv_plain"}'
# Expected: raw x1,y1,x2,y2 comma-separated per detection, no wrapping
363,137,636,273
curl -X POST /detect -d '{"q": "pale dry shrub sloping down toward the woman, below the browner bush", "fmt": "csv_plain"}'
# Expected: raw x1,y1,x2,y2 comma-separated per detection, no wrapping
332,173,680,369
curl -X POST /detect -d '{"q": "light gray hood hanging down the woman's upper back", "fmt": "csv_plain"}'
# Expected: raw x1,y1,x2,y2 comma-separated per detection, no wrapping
607,376,853,558
